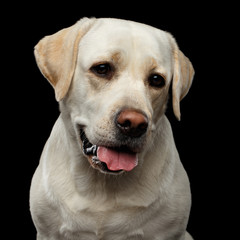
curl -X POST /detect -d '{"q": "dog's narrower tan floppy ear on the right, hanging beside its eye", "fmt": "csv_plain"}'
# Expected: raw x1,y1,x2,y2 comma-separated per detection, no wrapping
171,34,194,121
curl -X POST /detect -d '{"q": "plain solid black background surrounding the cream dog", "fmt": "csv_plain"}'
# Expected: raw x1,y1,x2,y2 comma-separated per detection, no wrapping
4,1,237,240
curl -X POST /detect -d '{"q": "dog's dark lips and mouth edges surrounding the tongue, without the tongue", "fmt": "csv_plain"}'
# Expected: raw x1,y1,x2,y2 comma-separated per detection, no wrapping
80,129,137,175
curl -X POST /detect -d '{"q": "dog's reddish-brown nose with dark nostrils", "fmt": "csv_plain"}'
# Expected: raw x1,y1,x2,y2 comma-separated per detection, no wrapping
116,109,148,137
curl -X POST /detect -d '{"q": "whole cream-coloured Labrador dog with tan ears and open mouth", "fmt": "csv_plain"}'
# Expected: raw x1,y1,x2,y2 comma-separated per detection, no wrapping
30,18,194,240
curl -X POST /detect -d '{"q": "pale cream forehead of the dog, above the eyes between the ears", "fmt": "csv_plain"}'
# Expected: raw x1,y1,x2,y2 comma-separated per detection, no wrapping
79,19,171,67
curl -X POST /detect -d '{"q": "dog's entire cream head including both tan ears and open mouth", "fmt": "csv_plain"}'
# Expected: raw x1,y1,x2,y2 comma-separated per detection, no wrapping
35,19,193,174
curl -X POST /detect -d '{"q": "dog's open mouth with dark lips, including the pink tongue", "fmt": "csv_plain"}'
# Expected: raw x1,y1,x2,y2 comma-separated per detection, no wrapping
80,129,138,175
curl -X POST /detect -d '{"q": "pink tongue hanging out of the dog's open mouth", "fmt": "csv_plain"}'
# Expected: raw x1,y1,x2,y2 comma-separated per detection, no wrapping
97,147,138,171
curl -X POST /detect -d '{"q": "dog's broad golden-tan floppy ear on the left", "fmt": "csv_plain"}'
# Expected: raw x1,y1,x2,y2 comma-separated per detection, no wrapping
34,18,96,101
